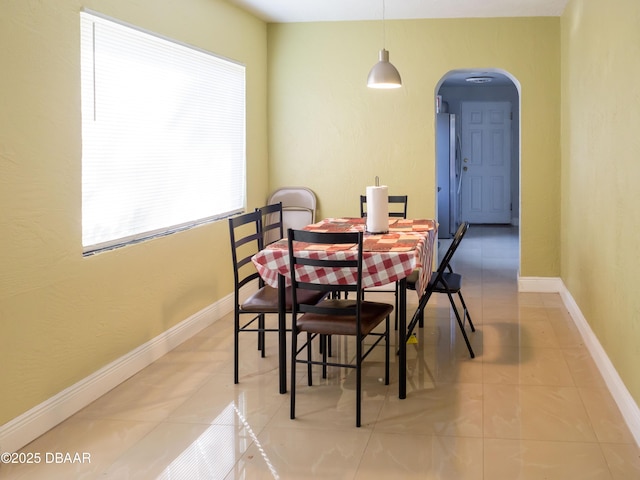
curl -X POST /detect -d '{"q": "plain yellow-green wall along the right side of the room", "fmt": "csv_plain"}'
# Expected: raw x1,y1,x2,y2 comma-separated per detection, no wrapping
561,0,640,404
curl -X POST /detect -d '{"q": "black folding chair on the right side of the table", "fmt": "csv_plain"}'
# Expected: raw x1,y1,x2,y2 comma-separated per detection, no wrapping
407,222,476,358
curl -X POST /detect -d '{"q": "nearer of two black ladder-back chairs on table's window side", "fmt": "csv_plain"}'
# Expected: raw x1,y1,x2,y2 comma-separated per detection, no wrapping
229,209,323,386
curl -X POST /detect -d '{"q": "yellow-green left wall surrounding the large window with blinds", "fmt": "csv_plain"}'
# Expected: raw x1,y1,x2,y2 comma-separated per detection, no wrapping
0,0,268,425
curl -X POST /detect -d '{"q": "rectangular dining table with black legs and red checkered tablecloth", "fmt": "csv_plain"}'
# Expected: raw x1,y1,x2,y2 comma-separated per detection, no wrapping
252,217,438,399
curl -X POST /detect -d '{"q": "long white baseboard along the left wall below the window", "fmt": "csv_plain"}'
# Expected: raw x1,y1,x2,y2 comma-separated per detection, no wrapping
0,295,233,452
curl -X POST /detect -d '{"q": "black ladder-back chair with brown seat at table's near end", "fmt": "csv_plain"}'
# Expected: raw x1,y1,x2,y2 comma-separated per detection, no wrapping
287,229,393,427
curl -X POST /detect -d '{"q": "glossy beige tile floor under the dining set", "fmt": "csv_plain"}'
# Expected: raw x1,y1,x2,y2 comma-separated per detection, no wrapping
0,226,640,480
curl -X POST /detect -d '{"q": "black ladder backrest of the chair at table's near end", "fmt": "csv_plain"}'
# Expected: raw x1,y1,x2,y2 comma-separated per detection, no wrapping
287,229,363,320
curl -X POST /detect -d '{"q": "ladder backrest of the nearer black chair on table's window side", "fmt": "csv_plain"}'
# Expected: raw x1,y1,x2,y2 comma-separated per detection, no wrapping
229,210,264,294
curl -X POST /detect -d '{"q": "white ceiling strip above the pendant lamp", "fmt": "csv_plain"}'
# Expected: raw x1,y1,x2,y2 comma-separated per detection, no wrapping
228,0,569,23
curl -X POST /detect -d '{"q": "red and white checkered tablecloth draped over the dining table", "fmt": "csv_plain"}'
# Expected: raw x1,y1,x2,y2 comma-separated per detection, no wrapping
253,218,437,296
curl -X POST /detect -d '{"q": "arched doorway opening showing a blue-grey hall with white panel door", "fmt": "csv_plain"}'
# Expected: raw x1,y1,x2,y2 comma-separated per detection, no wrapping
435,69,520,238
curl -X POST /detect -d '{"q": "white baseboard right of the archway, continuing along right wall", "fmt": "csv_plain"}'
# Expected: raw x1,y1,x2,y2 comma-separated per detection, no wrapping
518,276,640,447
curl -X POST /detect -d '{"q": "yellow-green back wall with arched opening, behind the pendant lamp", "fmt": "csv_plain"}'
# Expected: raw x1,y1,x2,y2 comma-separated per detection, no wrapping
268,17,560,277
